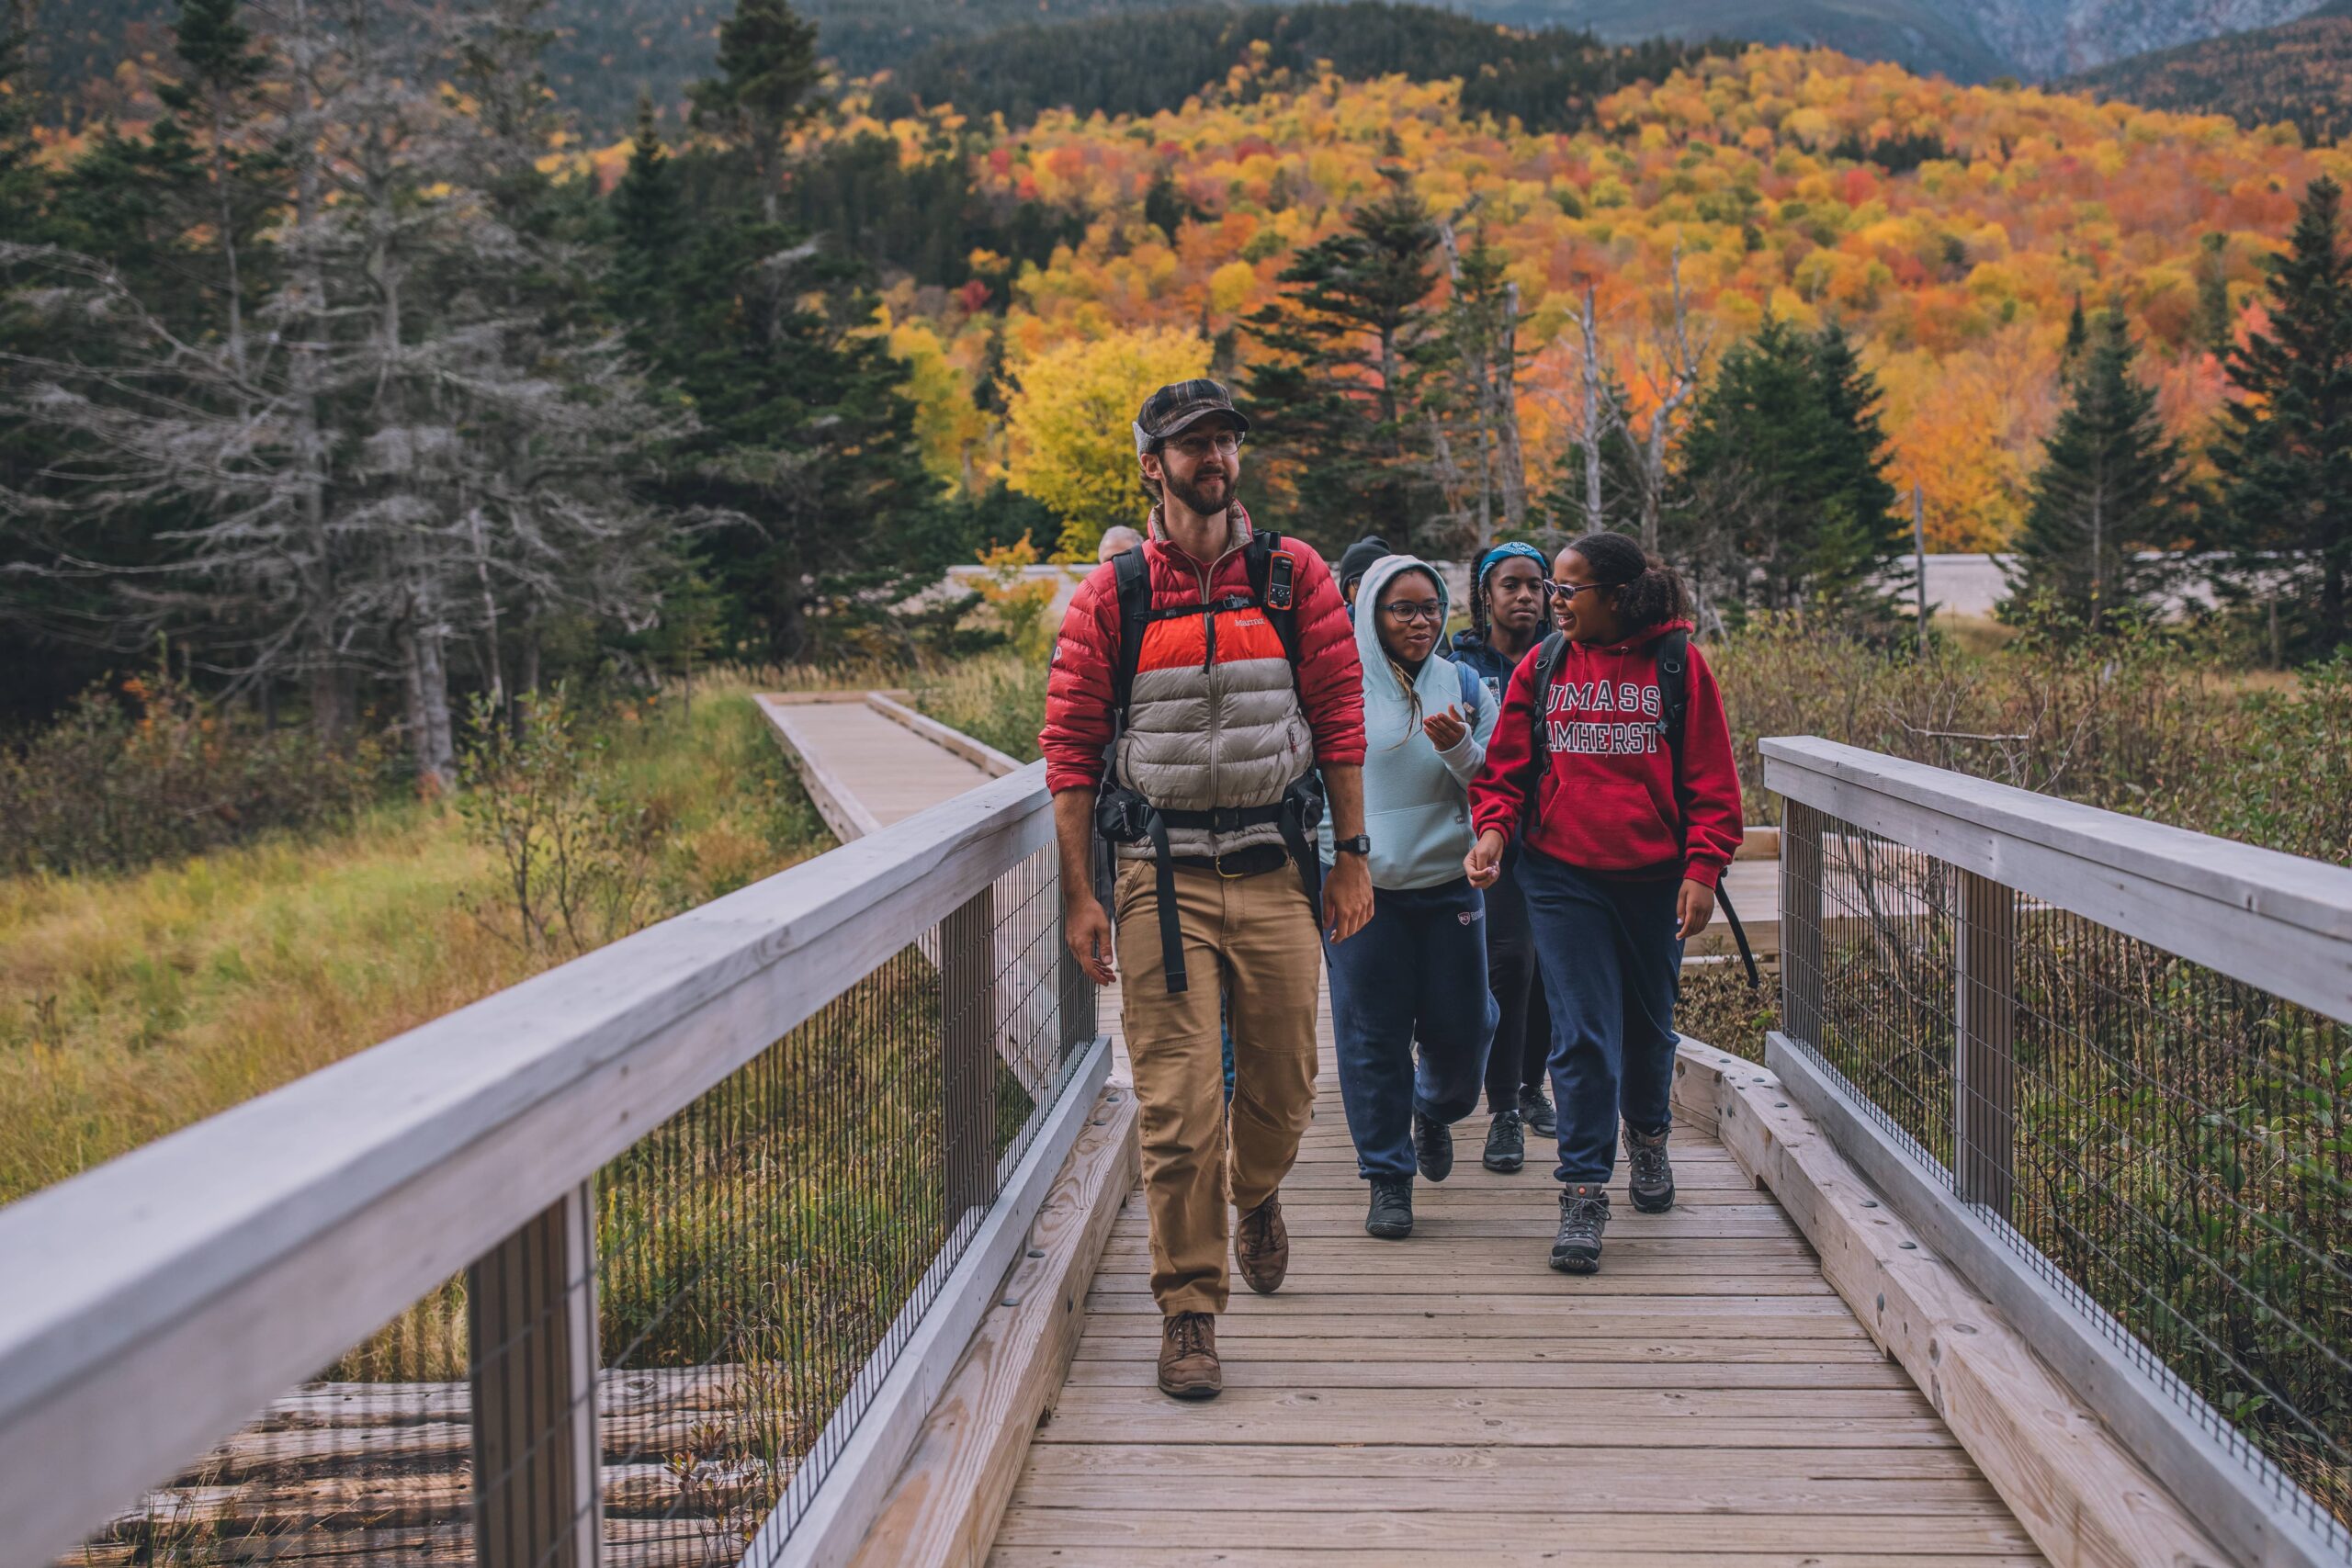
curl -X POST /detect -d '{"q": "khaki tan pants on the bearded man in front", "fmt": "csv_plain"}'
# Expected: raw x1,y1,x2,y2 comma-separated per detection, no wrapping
1117,861,1322,1314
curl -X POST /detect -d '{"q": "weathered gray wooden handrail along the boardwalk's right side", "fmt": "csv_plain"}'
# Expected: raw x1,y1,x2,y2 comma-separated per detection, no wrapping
1761,736,2352,1021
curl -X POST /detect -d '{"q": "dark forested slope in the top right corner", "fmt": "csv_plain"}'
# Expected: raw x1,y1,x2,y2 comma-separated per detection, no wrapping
2061,0,2352,143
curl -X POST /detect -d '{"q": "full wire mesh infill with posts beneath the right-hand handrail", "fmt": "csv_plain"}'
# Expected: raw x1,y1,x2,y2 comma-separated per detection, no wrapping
1782,802,2352,1554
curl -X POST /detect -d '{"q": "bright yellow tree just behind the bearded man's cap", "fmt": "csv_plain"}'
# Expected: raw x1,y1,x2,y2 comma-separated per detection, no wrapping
1007,327,1209,562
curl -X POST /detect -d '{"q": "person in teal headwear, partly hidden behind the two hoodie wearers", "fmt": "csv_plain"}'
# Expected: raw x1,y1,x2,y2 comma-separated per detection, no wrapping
1453,543,1557,1173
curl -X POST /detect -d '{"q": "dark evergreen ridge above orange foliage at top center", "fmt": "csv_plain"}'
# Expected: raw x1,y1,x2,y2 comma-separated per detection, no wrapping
875,0,1729,131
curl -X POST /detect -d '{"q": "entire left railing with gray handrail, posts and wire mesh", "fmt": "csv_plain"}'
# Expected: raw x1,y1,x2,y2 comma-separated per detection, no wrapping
0,764,1108,1565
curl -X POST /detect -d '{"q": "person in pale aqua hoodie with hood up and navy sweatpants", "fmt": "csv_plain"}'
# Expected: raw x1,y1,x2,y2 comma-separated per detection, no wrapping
1322,555,1500,1239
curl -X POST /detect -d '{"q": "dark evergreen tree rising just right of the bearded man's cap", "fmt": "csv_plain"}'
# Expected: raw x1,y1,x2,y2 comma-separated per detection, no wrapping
1247,172,1437,550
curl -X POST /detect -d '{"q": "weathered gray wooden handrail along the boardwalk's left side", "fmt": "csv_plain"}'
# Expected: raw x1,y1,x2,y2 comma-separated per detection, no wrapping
0,764,1051,1429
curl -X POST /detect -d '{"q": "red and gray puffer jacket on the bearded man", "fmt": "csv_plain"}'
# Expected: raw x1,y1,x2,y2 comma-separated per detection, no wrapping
1040,505,1364,861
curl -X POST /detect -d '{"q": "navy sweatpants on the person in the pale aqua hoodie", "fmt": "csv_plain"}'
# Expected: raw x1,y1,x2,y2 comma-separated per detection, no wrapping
1324,877,1496,1180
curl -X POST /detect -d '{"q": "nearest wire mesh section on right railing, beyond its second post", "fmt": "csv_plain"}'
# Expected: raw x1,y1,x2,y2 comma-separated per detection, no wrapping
1987,900,2352,1550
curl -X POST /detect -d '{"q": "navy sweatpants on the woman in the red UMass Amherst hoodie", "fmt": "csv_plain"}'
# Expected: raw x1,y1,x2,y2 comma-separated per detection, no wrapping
1520,849,1681,1187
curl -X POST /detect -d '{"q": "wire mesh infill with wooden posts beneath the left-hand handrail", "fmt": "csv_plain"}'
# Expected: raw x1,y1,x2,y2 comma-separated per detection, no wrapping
55,849,1093,1568
